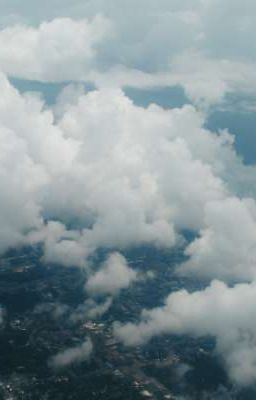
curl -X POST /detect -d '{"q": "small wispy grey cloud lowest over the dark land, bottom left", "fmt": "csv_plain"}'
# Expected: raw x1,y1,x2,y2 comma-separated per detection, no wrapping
49,338,93,368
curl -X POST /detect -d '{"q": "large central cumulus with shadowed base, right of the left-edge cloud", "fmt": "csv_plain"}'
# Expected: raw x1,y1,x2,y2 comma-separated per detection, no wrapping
20,83,244,266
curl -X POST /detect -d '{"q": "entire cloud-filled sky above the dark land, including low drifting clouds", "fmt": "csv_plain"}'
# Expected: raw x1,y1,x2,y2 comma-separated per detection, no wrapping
0,0,256,386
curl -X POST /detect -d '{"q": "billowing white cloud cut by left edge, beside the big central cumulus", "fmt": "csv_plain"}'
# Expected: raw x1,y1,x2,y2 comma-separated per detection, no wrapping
0,75,76,252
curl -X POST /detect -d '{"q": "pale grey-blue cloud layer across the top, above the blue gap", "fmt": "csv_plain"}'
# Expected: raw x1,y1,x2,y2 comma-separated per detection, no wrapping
0,0,256,105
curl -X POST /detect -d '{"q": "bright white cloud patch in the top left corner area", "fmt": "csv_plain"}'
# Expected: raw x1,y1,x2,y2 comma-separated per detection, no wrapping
0,16,110,81
